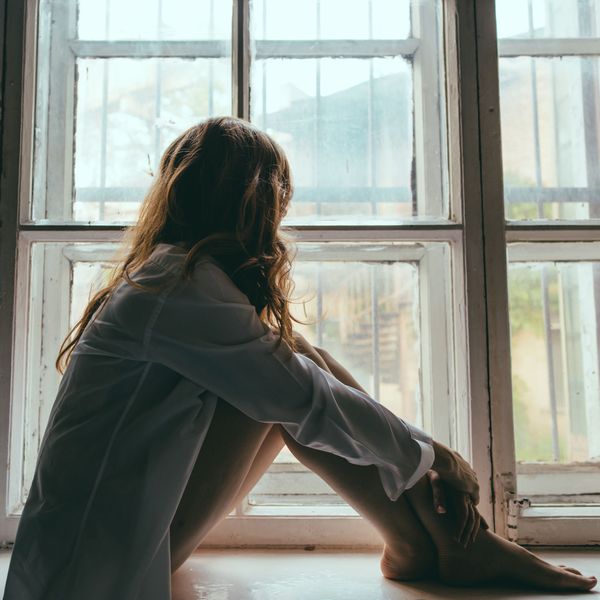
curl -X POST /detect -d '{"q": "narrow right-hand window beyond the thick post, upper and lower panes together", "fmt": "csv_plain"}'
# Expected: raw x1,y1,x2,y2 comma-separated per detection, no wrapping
496,0,600,542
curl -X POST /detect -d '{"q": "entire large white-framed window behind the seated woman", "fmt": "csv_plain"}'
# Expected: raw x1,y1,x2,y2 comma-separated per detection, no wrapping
0,0,600,545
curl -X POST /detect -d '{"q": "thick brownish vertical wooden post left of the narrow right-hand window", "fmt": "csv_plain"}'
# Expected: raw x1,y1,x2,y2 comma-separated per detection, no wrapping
473,0,516,536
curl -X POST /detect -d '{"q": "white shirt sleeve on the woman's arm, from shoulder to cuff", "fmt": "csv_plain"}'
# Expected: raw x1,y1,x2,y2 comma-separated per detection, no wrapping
144,262,434,500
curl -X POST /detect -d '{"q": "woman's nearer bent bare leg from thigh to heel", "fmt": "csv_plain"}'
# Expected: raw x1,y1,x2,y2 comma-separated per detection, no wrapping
171,356,436,579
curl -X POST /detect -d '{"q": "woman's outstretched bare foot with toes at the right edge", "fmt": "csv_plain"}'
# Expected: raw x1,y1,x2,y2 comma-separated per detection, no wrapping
438,530,597,592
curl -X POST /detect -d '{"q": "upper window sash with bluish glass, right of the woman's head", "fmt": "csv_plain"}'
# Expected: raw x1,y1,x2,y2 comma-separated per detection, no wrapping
250,0,448,224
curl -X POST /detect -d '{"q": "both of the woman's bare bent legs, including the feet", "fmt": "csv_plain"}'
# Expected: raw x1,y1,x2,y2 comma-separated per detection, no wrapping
171,349,596,590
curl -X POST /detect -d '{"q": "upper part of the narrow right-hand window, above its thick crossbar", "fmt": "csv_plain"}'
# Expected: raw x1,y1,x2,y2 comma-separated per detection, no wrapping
496,0,600,221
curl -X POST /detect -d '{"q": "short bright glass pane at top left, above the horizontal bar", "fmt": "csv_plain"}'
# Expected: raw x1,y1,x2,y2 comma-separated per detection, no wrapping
77,0,232,40
